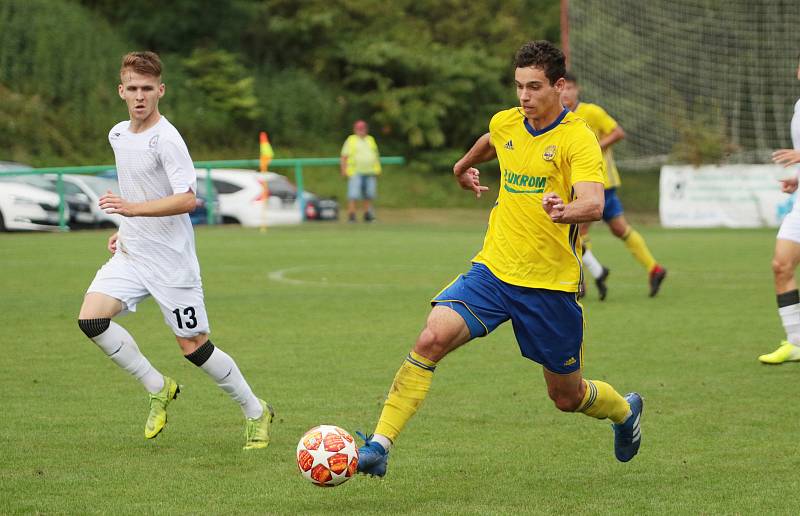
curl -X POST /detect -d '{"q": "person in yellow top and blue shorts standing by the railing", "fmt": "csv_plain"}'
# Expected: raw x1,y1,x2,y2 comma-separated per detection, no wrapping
340,120,381,222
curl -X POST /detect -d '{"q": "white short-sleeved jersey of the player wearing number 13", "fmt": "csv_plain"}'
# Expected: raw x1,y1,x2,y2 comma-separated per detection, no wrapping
108,116,201,287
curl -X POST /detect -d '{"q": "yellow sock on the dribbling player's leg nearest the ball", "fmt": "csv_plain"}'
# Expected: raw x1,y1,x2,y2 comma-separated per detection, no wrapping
375,351,436,442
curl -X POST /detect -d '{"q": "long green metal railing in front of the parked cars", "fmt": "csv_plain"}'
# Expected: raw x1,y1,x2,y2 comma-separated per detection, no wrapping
0,156,405,231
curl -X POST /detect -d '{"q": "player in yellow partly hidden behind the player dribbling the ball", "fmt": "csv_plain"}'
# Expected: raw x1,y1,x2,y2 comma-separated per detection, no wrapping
561,73,667,301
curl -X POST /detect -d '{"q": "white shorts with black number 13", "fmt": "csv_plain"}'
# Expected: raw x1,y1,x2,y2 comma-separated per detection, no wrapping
86,253,211,337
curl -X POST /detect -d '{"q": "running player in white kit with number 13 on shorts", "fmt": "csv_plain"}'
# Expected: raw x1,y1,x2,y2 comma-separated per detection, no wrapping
78,52,274,450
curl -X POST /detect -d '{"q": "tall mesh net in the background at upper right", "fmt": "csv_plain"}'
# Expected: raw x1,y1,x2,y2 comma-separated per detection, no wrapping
568,0,800,169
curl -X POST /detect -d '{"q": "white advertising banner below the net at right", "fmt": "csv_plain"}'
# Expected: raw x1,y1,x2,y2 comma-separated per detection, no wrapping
658,165,796,228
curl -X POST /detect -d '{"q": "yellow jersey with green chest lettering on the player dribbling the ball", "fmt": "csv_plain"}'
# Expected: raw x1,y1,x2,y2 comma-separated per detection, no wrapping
472,108,605,292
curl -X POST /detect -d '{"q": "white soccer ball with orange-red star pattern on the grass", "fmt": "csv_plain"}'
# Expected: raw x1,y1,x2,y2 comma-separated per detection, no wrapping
297,425,358,487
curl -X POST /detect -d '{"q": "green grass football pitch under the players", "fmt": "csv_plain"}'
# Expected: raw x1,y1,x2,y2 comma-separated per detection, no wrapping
0,212,800,514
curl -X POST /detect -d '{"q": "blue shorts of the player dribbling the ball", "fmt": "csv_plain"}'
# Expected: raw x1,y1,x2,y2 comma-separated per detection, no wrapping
431,263,583,374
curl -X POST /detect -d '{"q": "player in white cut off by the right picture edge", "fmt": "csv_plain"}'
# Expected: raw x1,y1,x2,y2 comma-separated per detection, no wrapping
758,56,800,364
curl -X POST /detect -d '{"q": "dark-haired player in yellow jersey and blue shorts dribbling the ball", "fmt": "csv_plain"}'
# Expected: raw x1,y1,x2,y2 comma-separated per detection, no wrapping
358,41,642,476
